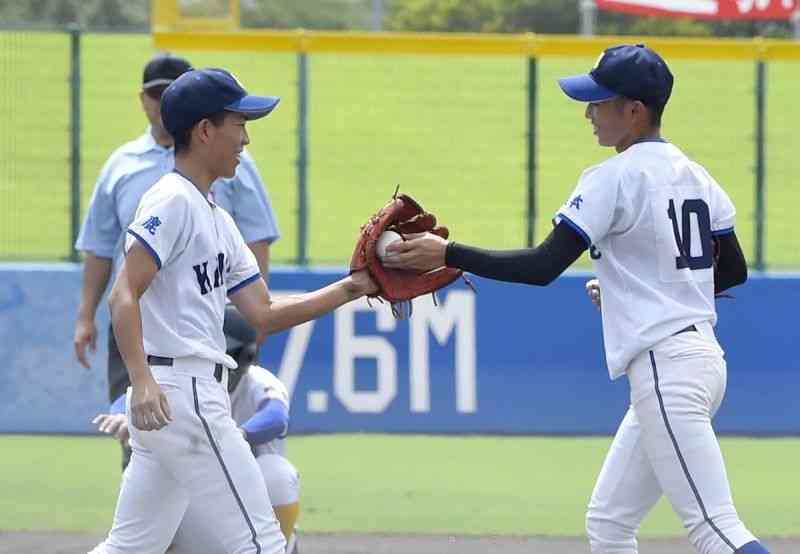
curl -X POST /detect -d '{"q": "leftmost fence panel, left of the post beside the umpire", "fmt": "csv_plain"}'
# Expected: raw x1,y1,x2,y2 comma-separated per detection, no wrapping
0,32,70,259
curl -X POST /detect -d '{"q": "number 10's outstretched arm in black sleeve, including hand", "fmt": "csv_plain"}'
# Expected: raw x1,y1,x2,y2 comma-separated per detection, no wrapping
383,223,589,286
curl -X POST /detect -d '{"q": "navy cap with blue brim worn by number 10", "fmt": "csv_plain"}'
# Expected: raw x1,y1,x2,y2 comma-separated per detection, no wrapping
558,44,674,108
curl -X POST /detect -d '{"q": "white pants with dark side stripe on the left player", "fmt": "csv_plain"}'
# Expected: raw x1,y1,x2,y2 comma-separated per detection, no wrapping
95,358,285,554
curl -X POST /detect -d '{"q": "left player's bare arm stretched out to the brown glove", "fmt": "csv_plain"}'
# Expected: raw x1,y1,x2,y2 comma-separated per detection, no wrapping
225,271,377,341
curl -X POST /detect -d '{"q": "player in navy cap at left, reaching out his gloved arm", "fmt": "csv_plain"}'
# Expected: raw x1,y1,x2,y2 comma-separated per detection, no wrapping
89,69,375,554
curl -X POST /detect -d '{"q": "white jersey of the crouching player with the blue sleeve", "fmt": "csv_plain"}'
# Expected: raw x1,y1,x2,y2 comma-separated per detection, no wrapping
231,365,289,456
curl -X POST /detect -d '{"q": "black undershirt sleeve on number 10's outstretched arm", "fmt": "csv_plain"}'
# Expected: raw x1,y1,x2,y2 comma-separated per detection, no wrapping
445,222,589,286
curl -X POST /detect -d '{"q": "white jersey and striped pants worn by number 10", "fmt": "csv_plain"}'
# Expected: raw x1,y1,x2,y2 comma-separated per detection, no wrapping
556,140,754,554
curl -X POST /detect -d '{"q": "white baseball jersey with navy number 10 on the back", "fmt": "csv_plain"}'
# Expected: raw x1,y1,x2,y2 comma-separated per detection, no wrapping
555,141,736,379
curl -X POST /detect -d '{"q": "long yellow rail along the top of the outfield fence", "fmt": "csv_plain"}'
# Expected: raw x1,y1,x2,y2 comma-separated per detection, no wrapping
153,29,800,60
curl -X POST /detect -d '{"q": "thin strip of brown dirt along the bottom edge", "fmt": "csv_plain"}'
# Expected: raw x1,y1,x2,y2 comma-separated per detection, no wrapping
0,532,800,554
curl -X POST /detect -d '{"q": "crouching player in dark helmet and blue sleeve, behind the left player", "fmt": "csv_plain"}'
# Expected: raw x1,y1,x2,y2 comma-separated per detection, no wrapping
94,304,300,554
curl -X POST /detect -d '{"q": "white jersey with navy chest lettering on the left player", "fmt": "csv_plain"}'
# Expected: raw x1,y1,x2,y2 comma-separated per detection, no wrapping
125,171,260,368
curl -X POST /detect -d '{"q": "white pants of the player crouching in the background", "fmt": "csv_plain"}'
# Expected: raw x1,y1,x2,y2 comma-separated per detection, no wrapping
173,454,300,554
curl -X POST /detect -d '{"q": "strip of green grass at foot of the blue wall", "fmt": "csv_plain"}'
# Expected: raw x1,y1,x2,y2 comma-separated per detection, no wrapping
0,435,800,536
